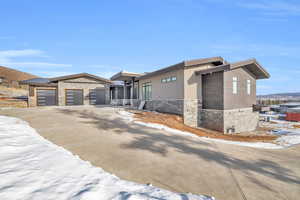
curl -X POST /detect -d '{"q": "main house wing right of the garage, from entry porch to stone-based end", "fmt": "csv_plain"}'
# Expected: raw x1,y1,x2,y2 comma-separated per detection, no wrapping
110,57,270,133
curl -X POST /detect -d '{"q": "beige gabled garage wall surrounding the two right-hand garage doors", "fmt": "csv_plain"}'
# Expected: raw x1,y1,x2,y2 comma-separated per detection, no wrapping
58,77,109,106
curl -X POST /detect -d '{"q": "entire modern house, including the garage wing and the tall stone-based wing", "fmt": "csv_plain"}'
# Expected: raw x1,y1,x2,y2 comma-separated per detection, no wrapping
21,57,270,133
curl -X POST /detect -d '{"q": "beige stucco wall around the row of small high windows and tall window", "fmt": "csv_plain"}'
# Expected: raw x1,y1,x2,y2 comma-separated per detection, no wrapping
139,69,183,100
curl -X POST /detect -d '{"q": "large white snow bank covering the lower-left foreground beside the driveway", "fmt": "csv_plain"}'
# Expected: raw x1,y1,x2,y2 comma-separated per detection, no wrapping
0,116,213,200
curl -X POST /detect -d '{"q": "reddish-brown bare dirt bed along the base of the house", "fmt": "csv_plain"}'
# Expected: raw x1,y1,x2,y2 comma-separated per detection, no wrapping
130,110,277,142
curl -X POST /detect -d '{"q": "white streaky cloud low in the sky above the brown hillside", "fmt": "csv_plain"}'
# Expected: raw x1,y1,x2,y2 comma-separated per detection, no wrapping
0,49,72,67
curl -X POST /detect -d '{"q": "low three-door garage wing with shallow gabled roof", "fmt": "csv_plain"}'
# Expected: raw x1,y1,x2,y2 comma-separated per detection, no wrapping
20,73,111,107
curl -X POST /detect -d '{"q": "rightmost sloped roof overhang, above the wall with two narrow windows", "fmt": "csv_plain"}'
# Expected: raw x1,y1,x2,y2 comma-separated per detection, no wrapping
231,59,270,79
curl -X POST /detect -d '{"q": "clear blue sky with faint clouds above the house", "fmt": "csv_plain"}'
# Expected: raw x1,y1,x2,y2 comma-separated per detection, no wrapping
0,0,300,94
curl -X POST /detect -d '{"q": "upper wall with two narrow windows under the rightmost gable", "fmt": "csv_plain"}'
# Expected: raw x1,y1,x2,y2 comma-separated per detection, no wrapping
224,68,256,110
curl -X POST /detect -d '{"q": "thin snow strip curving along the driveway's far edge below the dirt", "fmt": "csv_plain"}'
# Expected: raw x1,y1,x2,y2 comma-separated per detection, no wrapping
119,111,300,149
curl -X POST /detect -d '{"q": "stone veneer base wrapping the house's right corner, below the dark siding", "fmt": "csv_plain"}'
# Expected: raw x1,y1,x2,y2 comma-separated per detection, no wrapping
199,108,258,133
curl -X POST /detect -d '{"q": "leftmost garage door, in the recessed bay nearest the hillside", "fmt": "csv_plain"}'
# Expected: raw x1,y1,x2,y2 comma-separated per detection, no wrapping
37,89,57,106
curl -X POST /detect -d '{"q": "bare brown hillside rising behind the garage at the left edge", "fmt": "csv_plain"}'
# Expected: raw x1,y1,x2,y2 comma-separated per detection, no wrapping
0,66,38,82
